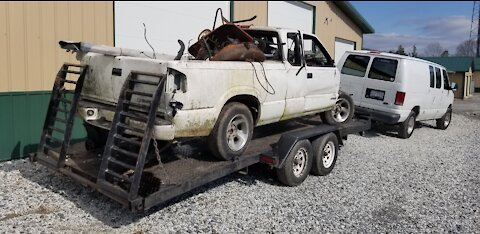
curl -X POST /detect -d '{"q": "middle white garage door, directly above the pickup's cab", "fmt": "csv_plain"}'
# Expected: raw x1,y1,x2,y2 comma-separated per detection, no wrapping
268,1,314,33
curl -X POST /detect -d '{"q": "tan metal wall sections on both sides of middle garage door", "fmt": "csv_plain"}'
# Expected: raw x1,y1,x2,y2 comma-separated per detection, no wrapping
233,1,363,57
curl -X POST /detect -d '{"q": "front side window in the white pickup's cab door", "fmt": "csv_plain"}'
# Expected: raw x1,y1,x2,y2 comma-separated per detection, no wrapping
303,34,333,67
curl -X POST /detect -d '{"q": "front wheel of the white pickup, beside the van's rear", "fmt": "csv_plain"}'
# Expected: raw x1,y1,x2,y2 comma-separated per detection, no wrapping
320,92,355,125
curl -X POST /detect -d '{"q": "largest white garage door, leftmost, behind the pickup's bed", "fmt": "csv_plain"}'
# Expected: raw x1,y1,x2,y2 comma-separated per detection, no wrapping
115,1,230,55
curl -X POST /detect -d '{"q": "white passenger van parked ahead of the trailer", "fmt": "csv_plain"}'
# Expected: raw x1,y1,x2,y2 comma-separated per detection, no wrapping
338,51,456,138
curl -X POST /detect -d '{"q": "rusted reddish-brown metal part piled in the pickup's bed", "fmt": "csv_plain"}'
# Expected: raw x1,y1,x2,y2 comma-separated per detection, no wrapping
210,42,265,62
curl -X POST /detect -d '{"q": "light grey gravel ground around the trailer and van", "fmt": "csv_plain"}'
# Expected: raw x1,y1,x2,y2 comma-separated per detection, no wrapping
0,114,480,233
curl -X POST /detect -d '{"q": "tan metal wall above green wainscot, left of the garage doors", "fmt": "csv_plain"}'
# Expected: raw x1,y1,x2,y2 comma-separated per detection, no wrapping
0,1,113,92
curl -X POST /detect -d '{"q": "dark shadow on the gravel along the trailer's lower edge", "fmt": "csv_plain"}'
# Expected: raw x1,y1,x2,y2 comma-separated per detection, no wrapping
0,157,281,228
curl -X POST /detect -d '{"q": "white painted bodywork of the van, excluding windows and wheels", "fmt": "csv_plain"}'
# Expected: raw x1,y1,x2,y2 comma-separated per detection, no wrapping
338,51,453,124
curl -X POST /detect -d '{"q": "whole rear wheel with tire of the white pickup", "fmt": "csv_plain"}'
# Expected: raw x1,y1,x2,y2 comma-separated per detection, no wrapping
208,102,253,160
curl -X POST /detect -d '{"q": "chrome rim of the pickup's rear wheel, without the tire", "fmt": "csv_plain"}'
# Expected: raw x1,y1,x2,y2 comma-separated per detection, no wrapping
226,114,249,151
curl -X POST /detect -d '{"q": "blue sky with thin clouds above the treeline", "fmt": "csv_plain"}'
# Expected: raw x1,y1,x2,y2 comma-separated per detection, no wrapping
350,1,473,55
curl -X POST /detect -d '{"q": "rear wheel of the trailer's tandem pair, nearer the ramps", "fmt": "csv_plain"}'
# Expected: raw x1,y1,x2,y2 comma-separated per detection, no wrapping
276,140,313,186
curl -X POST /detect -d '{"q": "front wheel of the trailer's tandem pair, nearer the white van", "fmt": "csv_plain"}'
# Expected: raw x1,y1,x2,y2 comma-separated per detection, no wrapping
312,133,338,176
